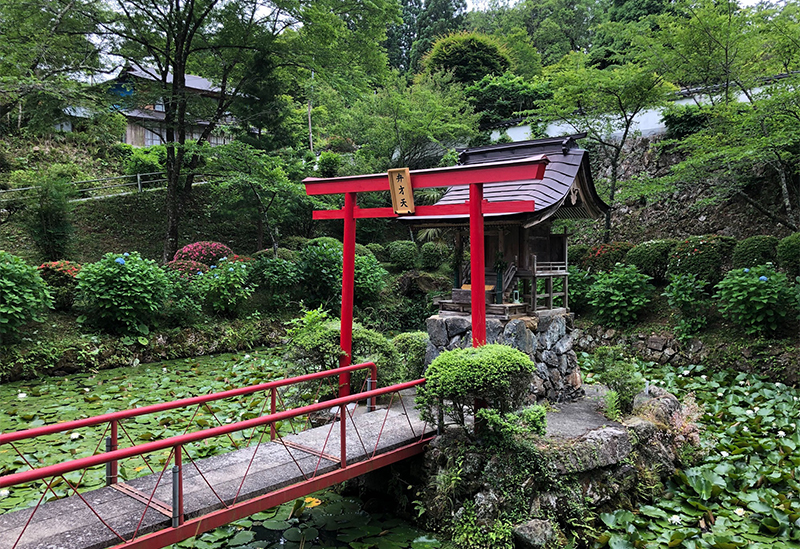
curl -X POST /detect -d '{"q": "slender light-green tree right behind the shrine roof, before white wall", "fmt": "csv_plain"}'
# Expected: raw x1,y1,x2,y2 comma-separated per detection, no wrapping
535,54,674,242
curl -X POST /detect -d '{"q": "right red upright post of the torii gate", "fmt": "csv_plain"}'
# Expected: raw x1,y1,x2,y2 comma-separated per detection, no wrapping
469,183,486,347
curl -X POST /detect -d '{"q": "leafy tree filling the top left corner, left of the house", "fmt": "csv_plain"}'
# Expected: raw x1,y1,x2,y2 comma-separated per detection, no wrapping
0,0,102,125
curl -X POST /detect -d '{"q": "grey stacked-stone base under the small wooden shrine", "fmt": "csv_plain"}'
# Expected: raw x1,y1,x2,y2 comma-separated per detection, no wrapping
425,309,584,402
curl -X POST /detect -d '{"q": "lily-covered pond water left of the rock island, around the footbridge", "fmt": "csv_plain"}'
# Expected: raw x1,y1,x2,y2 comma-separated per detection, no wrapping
0,349,440,549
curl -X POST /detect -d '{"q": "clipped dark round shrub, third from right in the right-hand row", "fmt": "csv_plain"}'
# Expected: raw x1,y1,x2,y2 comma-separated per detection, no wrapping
667,235,736,285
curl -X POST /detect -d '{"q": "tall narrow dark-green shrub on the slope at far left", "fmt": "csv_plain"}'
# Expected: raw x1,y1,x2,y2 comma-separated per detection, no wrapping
26,176,74,261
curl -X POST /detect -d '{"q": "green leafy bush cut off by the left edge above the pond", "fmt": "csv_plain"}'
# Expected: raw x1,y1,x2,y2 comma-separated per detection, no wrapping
0,250,52,343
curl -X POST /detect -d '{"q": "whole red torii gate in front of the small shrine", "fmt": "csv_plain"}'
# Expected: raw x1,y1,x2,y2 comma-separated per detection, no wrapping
303,155,548,396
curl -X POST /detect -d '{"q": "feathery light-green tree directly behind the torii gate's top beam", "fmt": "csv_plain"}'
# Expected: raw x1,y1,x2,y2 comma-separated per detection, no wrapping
336,74,478,171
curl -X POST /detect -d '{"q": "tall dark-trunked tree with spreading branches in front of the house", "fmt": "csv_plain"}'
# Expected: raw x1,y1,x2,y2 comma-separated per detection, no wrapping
101,0,397,262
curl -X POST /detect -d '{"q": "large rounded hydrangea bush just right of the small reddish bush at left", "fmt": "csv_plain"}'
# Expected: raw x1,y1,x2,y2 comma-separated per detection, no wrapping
78,252,169,335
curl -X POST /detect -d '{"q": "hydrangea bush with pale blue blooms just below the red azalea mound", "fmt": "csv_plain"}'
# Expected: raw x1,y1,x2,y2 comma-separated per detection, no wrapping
197,258,257,317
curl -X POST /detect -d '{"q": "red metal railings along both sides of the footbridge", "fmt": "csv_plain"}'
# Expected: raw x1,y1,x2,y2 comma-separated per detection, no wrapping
0,362,429,548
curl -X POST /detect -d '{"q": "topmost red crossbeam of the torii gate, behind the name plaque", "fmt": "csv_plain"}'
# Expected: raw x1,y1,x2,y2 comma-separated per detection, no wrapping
303,154,549,196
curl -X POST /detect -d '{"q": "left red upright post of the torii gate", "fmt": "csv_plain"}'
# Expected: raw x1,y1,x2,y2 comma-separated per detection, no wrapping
339,193,356,396
